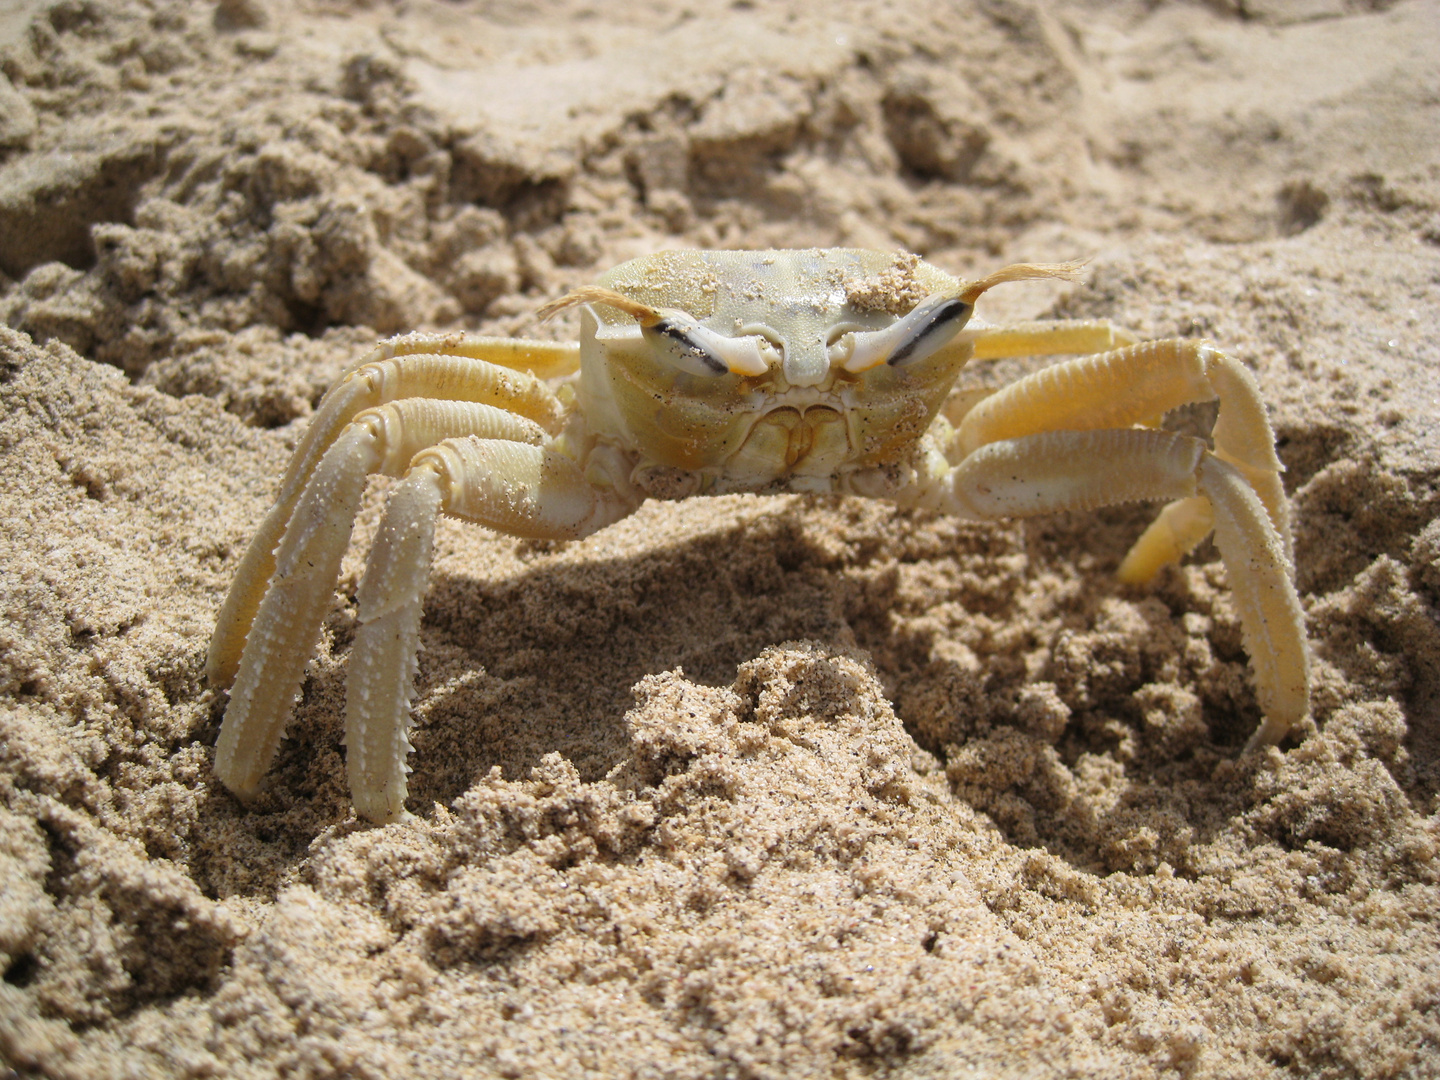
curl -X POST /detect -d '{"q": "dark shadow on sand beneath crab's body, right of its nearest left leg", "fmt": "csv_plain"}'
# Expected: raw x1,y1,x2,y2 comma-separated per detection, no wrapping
394,508,852,806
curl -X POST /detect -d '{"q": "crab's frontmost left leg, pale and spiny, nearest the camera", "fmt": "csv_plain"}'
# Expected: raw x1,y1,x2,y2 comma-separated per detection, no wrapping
346,438,636,824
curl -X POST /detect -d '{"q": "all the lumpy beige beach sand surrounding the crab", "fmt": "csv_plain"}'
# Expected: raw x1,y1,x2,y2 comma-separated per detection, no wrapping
0,0,1440,1080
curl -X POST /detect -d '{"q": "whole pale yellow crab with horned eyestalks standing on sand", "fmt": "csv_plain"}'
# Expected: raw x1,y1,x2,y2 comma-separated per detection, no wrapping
207,249,1309,824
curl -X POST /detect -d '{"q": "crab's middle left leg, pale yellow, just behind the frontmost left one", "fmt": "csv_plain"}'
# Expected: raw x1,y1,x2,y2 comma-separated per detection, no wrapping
215,397,546,796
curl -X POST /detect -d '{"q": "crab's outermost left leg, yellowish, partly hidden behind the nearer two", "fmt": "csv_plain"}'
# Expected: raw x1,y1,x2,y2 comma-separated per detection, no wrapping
206,334,577,687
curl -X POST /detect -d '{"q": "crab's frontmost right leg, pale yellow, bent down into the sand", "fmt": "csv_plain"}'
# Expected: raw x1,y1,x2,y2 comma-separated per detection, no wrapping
942,429,1309,749
